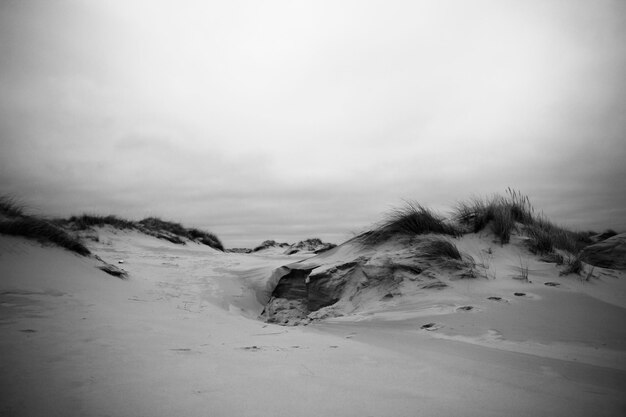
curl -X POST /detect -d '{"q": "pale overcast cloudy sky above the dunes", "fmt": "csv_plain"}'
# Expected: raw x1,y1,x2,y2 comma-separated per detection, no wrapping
0,0,626,247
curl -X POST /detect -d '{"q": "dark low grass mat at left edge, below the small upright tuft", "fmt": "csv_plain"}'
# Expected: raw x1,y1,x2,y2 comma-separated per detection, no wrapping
0,216,91,256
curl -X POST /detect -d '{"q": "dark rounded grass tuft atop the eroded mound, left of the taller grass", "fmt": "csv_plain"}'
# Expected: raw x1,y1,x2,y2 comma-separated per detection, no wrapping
360,202,461,244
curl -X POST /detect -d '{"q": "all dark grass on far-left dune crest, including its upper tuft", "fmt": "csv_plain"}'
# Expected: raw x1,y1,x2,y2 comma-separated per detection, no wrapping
0,196,91,256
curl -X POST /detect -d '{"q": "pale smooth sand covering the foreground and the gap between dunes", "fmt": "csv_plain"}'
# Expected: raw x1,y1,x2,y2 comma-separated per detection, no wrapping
0,228,626,417
